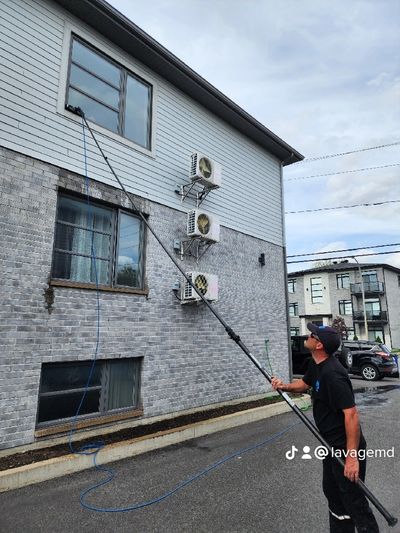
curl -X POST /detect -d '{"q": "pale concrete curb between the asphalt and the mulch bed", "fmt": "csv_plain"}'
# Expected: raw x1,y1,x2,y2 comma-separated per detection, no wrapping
0,396,310,492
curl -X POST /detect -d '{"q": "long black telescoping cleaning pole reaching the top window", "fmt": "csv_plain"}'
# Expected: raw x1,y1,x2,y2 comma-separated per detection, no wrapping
67,106,397,527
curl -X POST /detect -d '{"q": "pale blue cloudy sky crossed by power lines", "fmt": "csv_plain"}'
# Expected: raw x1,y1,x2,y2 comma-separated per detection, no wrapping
110,0,400,270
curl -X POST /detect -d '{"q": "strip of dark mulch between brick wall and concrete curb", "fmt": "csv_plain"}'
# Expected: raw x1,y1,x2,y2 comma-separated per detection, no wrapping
0,395,296,470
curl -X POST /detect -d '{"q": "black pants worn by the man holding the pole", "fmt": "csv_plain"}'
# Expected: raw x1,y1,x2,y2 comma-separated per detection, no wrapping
322,437,379,533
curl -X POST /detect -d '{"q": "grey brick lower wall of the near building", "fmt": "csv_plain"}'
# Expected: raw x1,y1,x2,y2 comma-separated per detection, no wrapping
0,148,288,448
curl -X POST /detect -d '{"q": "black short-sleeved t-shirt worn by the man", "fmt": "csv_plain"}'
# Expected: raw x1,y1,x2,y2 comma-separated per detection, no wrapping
303,356,355,448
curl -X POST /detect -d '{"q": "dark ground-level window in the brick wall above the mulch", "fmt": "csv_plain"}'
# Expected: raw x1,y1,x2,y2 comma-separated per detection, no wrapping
37,358,141,424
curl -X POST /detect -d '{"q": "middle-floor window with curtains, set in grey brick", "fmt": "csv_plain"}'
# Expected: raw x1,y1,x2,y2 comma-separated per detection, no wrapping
52,195,144,289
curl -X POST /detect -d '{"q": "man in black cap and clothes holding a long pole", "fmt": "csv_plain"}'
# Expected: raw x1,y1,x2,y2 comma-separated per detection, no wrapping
272,323,379,533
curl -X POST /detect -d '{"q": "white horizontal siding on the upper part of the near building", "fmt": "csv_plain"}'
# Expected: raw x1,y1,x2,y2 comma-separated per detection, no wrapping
0,0,283,245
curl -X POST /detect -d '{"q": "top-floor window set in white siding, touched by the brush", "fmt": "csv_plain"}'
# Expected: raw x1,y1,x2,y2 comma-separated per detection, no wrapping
66,37,152,149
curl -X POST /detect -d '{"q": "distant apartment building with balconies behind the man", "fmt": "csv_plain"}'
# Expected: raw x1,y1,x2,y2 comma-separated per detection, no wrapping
288,261,400,348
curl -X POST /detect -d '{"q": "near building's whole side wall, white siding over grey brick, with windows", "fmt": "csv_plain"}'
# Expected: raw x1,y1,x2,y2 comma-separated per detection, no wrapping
0,0,302,449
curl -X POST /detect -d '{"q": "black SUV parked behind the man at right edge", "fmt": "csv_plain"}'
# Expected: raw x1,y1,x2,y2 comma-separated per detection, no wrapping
343,341,399,381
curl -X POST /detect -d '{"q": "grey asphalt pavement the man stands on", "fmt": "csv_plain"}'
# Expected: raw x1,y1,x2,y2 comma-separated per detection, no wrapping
0,378,400,533
